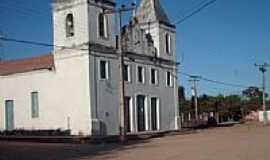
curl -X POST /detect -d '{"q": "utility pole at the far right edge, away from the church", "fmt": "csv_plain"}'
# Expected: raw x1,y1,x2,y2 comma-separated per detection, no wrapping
255,63,270,124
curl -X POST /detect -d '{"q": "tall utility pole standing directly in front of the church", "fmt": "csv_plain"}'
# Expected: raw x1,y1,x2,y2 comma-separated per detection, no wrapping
103,3,136,142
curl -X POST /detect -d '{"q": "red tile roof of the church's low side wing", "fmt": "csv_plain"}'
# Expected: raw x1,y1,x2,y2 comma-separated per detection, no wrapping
0,54,54,76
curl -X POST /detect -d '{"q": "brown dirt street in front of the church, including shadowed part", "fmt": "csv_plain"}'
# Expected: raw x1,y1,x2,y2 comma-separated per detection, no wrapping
0,124,270,160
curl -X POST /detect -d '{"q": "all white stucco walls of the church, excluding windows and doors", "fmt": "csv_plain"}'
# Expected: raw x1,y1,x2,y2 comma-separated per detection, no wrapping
0,0,178,135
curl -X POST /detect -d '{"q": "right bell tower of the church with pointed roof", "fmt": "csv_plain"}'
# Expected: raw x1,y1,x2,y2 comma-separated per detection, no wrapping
137,0,176,60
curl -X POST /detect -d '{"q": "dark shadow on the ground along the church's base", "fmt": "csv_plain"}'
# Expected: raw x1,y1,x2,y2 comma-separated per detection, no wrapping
0,140,153,160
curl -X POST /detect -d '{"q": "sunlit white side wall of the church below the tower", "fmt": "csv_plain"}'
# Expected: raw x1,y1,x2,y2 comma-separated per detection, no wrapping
0,52,91,134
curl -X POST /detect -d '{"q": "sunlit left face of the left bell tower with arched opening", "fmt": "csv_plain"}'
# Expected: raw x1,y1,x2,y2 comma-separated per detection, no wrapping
53,0,90,51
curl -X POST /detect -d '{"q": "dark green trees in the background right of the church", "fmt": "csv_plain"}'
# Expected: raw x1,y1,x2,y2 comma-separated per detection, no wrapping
179,87,270,121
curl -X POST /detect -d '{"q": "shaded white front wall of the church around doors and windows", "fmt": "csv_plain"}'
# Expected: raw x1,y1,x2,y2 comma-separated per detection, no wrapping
90,53,179,135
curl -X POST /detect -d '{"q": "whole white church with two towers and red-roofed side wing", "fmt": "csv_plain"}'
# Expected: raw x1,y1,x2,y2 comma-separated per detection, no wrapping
0,0,180,135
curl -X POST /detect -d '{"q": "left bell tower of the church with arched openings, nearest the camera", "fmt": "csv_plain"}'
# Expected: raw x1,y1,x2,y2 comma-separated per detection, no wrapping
53,0,115,51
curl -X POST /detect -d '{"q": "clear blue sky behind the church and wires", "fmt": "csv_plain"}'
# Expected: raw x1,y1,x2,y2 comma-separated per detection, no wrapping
0,0,270,97
